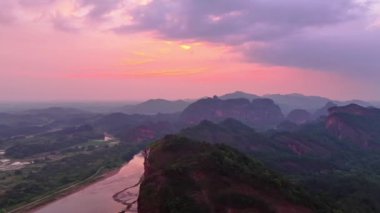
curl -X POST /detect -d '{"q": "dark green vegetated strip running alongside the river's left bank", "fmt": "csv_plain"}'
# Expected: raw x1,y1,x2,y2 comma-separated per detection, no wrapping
0,141,144,209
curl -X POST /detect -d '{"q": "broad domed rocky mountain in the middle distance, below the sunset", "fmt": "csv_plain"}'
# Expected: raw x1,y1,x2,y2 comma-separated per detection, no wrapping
180,97,284,129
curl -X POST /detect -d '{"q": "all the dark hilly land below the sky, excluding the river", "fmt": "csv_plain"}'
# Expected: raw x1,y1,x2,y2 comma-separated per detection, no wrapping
0,92,380,213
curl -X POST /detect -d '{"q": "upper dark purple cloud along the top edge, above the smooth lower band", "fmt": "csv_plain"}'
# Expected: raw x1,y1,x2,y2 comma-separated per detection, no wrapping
118,0,365,44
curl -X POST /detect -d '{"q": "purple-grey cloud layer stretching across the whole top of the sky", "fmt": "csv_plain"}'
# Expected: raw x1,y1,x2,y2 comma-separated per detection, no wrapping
0,0,380,76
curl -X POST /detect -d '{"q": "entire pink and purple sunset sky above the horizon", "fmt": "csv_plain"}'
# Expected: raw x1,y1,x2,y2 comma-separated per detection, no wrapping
0,0,380,102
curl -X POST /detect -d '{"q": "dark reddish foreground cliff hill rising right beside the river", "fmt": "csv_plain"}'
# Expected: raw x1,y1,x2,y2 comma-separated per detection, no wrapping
138,136,315,213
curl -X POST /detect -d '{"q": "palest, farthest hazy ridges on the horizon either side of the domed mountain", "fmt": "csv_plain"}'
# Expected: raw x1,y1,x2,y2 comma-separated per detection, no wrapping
0,91,380,114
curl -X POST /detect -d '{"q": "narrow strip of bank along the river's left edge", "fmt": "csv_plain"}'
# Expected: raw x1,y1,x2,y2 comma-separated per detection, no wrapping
8,166,122,213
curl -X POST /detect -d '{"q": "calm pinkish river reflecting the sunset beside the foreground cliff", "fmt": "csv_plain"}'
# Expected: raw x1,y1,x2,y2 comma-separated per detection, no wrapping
33,154,144,213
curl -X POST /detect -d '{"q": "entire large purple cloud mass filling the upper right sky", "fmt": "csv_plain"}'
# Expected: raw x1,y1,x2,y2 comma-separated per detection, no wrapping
115,0,380,73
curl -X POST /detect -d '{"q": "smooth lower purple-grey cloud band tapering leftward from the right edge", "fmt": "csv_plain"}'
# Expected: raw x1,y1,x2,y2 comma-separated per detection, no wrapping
244,24,380,74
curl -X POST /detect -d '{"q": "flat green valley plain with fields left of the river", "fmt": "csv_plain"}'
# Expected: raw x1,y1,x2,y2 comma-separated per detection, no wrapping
0,107,176,210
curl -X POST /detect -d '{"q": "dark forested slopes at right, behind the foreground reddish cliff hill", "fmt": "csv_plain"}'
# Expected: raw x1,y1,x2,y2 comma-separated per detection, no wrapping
182,116,380,213
